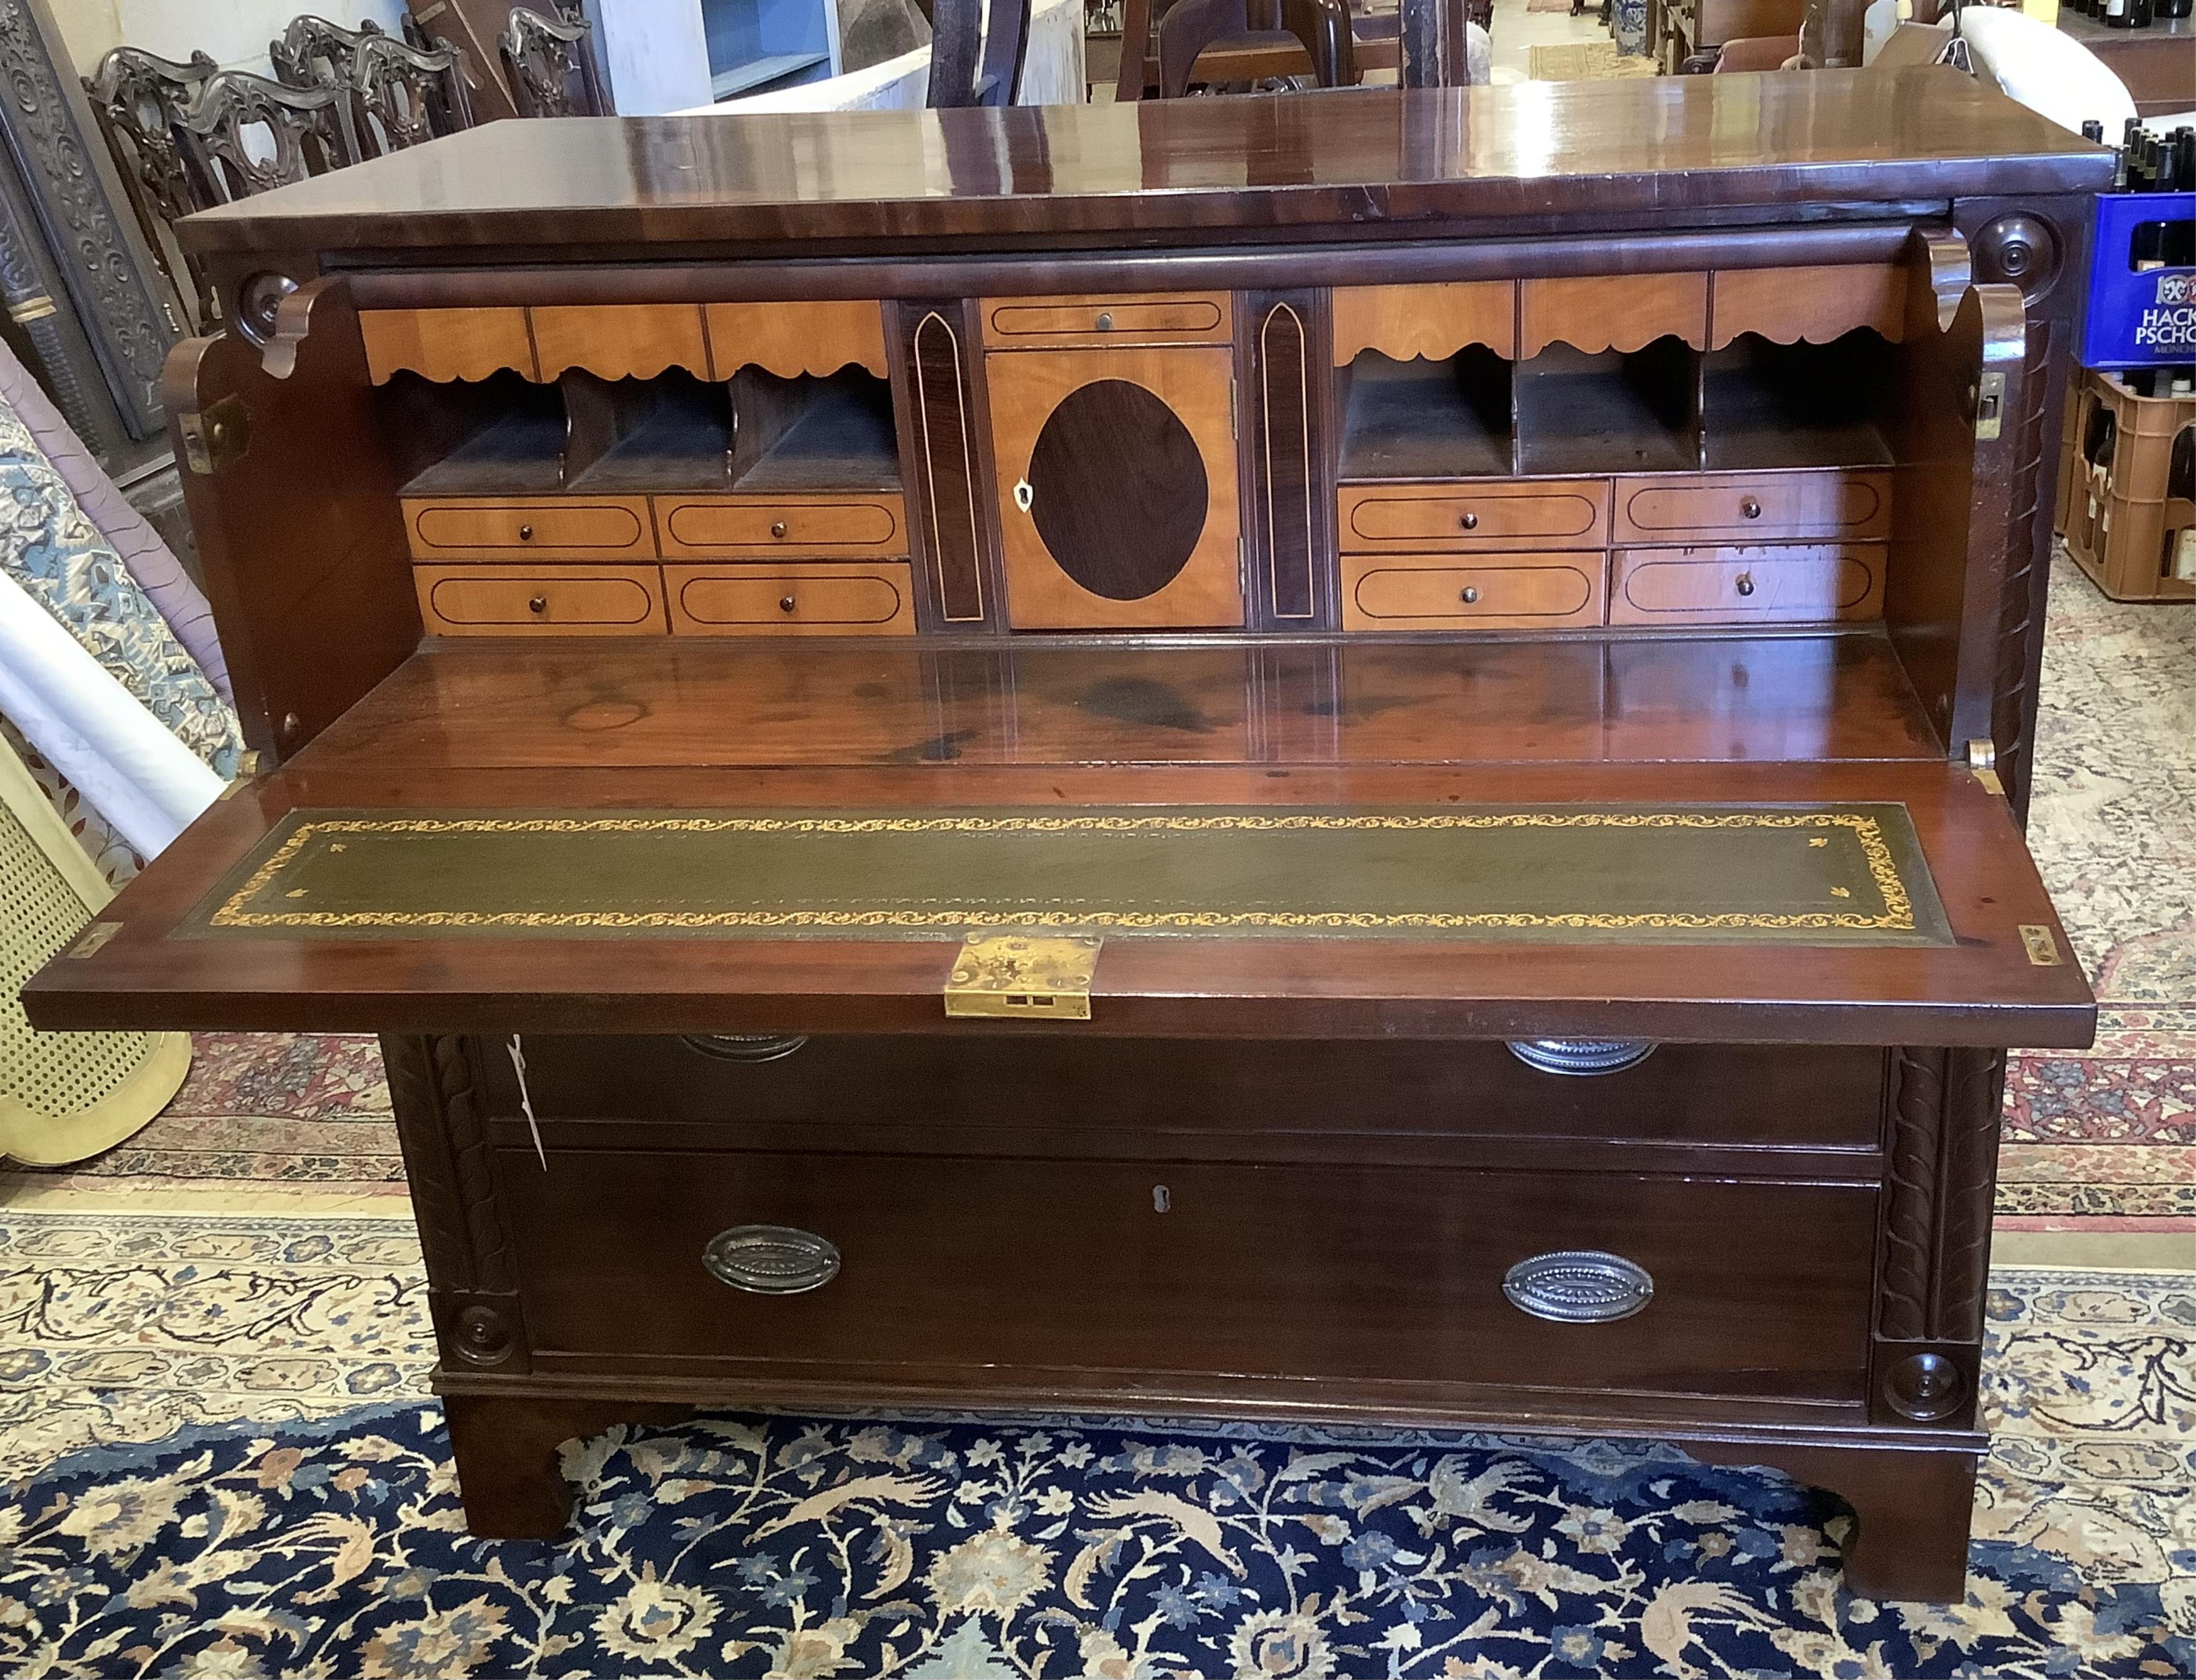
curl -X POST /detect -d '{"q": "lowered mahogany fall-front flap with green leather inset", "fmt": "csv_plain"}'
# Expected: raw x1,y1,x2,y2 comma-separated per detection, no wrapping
26,790,2095,1045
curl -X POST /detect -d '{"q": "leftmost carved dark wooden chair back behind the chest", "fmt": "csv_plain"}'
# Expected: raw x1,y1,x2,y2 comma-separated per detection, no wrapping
84,46,220,325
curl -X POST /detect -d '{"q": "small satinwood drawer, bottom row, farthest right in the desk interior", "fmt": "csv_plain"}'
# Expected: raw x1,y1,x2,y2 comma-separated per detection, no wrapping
1609,542,1884,623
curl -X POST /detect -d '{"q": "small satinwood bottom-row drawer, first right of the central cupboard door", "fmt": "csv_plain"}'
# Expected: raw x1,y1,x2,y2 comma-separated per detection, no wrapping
1342,549,1607,630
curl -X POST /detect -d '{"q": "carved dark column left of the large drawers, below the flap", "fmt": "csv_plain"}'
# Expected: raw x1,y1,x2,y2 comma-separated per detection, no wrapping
382,1035,531,1372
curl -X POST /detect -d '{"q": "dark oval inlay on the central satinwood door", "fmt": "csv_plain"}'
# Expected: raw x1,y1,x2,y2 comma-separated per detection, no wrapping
1030,380,1210,602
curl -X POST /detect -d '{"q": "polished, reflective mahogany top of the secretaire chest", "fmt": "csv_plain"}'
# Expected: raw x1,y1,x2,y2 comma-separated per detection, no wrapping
182,68,2110,257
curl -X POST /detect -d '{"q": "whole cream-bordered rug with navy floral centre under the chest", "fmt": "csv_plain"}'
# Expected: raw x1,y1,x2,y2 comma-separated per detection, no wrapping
0,1212,2196,1680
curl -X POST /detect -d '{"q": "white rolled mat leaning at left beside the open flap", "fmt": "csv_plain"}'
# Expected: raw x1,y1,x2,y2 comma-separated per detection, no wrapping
0,573,222,859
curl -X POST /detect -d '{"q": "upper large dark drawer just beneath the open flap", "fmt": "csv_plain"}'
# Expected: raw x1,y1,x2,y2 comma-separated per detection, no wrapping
477,1035,1884,1171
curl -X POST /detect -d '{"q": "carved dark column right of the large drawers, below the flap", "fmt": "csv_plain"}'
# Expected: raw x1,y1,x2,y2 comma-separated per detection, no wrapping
1869,1050,2005,1428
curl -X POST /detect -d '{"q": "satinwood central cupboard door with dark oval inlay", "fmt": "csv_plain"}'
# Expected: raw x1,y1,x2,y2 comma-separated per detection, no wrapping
984,347,1243,630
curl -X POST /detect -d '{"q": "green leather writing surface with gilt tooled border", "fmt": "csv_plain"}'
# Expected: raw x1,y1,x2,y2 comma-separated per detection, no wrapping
189,804,1950,945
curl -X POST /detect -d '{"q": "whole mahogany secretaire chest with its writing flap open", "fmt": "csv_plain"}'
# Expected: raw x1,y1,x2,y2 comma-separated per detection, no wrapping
28,70,2110,1599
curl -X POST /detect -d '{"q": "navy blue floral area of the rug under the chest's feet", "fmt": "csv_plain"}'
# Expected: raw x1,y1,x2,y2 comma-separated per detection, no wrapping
0,1406,2196,1680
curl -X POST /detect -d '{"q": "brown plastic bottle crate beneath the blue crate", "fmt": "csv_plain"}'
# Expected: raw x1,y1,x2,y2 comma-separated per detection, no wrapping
2058,371,2196,602
